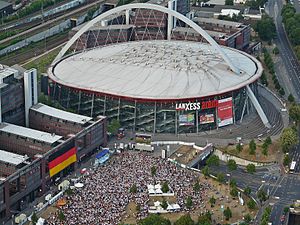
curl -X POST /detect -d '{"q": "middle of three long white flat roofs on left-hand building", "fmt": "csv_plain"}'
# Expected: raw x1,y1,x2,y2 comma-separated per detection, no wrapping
0,123,62,144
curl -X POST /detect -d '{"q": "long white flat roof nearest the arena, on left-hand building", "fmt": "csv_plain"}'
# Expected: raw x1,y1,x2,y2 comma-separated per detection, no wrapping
30,103,93,124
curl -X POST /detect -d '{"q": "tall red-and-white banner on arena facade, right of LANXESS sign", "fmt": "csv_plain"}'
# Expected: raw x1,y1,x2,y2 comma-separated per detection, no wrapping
217,97,233,127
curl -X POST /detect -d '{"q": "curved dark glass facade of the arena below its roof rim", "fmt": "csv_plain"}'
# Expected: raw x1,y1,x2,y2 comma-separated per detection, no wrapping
50,83,253,134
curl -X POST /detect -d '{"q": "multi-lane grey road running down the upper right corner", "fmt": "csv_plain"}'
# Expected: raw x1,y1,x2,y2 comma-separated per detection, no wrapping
266,0,300,102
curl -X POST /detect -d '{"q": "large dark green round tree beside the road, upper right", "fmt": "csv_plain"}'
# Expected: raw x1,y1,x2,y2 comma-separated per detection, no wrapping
254,15,276,41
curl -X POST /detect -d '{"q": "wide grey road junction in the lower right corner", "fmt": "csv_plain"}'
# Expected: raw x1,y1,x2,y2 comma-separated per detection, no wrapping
211,162,300,225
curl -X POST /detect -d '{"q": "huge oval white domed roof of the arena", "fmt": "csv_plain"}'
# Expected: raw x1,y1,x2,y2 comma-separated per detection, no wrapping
49,41,262,100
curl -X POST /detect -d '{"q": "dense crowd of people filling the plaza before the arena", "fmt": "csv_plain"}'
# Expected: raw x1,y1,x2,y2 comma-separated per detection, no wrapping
48,151,210,225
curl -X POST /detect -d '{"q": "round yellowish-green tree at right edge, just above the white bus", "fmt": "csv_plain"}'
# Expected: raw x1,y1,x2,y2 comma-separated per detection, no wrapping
280,127,299,152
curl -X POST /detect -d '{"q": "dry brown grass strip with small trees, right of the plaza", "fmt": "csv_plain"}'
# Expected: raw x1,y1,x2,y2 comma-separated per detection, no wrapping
218,141,281,162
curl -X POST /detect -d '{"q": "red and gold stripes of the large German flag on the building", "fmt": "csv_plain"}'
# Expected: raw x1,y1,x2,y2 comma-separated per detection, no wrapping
49,147,77,177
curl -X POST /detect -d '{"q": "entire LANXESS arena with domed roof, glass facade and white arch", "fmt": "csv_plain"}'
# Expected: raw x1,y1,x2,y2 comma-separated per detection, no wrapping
48,4,268,133
